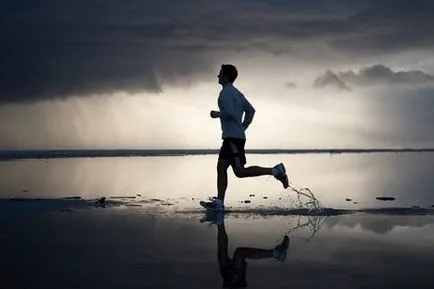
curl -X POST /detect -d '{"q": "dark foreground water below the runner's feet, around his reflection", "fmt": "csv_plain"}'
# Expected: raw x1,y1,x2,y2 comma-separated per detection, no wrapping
0,208,434,288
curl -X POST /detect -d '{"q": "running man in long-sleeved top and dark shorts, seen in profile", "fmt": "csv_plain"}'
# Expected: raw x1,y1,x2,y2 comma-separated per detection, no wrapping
202,64,288,210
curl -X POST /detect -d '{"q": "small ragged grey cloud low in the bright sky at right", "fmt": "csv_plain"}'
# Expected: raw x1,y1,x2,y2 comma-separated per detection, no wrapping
313,64,434,90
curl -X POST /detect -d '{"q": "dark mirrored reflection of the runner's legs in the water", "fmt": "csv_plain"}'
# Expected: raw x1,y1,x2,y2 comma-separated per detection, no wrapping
203,213,289,288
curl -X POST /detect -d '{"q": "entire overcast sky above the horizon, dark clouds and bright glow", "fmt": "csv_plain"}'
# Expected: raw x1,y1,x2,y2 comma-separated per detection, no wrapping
0,0,434,149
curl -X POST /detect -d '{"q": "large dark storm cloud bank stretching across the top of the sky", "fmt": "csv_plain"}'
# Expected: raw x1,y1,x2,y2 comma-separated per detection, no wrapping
0,0,434,102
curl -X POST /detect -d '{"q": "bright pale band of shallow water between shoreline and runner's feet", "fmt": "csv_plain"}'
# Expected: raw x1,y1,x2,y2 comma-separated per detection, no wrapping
0,153,434,209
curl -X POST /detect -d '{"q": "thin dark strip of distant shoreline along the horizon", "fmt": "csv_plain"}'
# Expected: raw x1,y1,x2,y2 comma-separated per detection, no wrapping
0,148,434,161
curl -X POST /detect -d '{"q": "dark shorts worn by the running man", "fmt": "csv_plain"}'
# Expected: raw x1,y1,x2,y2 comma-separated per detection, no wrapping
219,138,246,167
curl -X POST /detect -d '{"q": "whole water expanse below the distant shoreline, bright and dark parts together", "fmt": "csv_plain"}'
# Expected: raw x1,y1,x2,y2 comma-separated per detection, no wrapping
0,153,434,289
